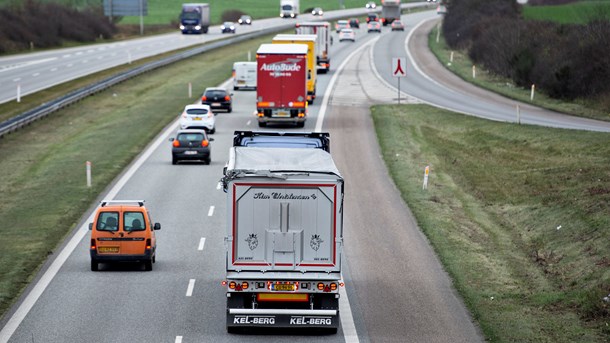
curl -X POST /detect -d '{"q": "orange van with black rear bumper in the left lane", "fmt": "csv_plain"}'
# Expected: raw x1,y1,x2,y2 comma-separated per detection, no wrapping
89,200,161,271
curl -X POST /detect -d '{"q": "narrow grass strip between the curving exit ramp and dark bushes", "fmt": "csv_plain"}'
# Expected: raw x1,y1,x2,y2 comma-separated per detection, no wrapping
428,23,610,121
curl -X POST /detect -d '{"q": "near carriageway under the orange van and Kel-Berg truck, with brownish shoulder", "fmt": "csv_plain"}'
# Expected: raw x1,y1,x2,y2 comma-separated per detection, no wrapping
0,12,482,342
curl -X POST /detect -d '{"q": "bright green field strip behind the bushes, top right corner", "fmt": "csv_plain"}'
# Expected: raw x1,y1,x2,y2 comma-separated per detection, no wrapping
523,1,610,24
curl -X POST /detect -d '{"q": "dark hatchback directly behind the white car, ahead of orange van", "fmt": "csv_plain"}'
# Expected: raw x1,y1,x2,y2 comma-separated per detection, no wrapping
169,129,214,164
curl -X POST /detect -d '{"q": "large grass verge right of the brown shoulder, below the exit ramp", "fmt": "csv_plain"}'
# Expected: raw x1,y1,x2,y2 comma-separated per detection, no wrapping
372,105,610,342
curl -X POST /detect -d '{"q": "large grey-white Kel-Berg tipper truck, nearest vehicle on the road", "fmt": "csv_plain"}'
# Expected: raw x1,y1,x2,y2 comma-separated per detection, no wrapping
222,140,344,333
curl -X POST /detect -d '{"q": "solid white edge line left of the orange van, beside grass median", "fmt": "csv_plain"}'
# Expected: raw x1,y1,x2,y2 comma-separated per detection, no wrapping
0,119,178,343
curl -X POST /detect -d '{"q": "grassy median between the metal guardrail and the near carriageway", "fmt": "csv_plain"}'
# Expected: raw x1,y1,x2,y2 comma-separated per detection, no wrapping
0,32,272,322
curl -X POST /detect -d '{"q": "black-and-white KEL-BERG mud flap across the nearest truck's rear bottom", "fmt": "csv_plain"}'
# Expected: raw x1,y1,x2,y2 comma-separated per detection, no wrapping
227,309,339,328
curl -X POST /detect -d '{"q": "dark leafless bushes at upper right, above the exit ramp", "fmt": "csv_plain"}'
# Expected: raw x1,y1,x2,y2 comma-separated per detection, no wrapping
442,0,610,108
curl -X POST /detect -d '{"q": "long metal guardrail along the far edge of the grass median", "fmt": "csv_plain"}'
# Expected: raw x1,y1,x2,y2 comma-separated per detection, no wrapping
0,3,426,138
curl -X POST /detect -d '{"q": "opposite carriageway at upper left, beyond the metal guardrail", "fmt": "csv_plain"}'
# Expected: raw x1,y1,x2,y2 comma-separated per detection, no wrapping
0,3,426,104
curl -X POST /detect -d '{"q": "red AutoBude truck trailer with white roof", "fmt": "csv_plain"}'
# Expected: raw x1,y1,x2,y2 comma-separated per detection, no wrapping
256,44,308,127
